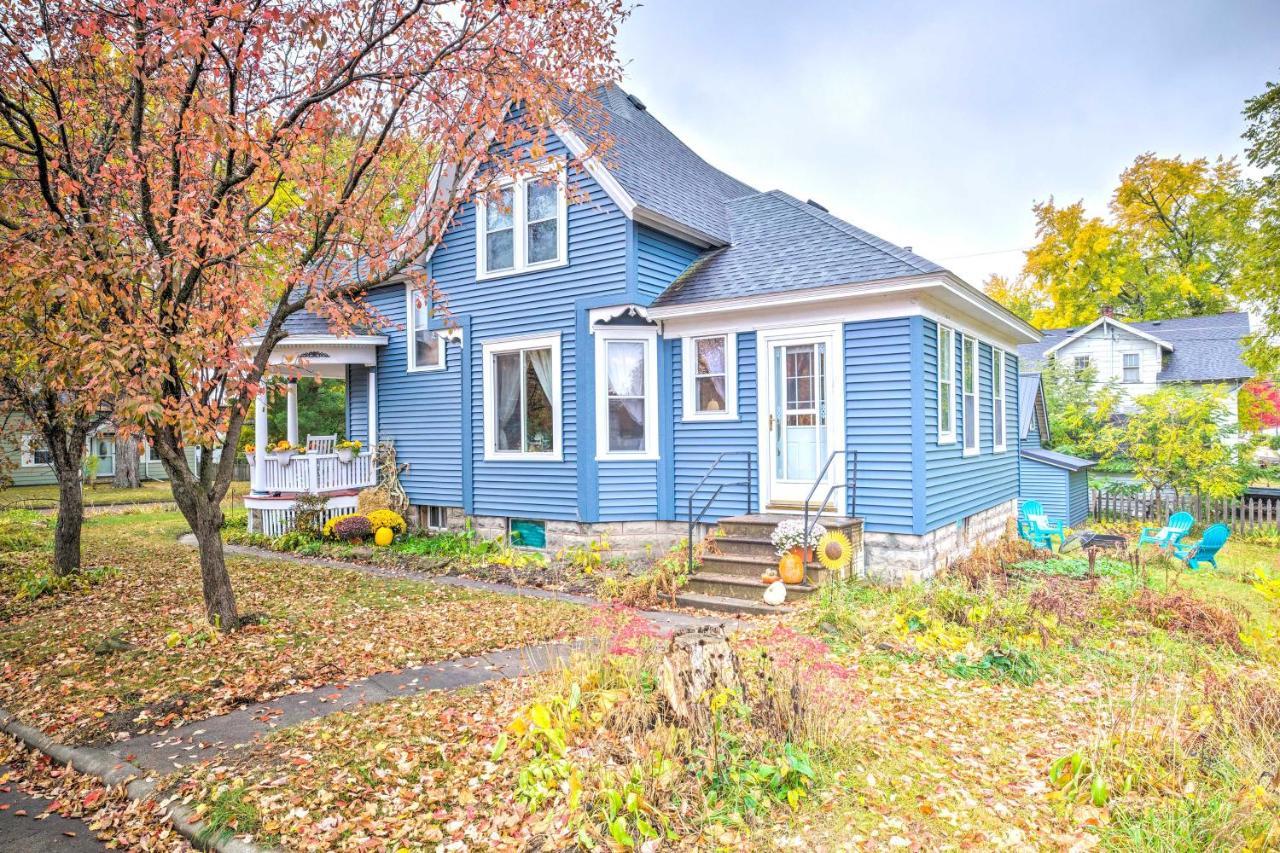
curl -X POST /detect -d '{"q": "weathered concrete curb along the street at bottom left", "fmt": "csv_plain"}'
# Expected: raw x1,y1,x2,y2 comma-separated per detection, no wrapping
0,708,271,853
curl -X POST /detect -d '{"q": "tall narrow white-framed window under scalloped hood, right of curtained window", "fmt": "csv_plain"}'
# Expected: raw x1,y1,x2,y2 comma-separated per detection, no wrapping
595,329,658,460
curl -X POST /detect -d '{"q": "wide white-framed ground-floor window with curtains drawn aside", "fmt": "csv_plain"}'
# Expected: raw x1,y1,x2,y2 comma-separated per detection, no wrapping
484,334,561,460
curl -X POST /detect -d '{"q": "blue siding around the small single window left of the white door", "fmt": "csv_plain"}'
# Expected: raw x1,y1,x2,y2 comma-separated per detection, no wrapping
671,332,760,521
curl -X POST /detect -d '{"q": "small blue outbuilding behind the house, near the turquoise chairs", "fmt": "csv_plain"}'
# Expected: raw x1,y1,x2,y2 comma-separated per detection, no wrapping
1018,373,1096,528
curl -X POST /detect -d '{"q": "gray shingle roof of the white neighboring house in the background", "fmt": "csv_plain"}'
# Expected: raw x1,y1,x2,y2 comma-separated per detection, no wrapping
1018,311,1253,382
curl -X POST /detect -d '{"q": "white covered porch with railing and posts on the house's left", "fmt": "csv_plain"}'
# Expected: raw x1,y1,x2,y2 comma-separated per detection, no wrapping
244,334,387,537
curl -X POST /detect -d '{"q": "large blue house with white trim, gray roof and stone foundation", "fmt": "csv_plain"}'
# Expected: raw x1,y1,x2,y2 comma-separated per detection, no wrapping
240,87,1039,583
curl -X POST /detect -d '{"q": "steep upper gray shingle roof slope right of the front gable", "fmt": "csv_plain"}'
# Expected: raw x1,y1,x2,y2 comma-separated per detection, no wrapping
570,86,755,243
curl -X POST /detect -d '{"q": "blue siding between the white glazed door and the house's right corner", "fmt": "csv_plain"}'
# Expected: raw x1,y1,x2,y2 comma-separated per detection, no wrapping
836,318,919,533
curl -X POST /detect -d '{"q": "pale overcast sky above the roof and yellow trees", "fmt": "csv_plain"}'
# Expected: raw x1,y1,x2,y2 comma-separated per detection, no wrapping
620,0,1280,284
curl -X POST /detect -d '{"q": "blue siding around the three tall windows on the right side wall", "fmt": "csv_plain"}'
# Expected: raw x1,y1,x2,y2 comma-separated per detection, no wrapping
918,319,1018,533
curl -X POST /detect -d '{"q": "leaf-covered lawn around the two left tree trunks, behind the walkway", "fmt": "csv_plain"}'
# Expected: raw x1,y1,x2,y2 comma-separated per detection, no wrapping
0,512,590,742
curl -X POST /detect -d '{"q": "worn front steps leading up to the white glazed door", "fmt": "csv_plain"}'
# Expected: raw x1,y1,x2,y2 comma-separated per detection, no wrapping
676,512,863,613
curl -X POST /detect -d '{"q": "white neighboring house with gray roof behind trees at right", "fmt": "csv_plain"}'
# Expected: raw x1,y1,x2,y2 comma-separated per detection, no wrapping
1018,313,1253,424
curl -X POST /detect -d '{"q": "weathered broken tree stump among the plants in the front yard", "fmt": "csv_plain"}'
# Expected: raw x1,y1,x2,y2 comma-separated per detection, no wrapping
658,625,739,727
